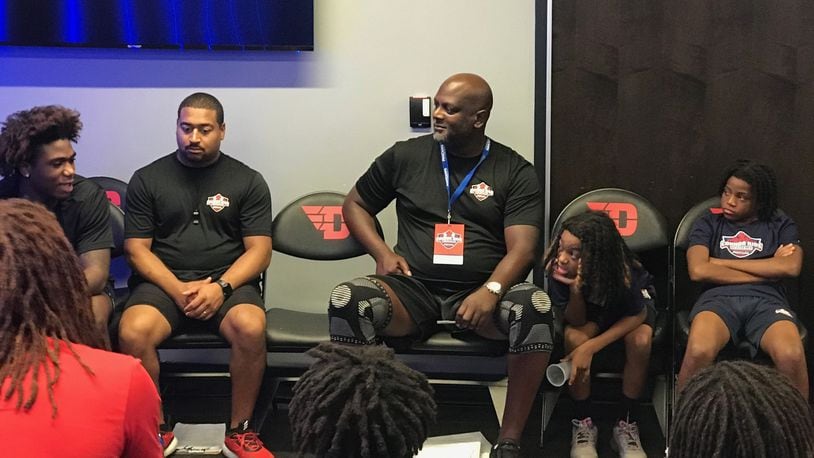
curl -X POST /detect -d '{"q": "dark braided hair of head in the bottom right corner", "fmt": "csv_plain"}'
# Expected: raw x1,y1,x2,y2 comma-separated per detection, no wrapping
670,361,814,458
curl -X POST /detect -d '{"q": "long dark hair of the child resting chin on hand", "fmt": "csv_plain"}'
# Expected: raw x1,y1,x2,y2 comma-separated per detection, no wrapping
543,211,641,306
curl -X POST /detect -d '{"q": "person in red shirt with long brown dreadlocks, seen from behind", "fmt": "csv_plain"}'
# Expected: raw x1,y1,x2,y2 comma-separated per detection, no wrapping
0,199,162,458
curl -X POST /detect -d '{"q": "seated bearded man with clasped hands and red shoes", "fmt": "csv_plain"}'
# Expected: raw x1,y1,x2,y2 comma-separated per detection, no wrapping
119,92,272,458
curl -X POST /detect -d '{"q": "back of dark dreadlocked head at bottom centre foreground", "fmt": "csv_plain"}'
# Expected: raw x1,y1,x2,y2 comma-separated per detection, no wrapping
289,343,436,458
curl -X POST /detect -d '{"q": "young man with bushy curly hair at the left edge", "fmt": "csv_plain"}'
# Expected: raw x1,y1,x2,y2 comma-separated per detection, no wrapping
0,105,113,337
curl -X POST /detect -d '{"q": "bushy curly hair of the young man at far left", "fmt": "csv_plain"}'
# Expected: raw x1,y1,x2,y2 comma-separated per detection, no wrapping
0,105,82,177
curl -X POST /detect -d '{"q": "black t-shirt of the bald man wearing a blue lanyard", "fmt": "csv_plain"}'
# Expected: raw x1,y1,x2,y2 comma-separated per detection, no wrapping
356,135,543,292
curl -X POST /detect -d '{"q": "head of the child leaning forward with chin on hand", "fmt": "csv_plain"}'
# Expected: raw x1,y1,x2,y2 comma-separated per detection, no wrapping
543,211,638,305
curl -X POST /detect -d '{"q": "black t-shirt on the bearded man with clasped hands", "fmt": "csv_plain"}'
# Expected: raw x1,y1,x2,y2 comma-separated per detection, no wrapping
125,153,271,284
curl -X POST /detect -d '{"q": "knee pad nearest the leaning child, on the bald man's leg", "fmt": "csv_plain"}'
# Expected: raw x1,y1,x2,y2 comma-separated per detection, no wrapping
496,283,554,353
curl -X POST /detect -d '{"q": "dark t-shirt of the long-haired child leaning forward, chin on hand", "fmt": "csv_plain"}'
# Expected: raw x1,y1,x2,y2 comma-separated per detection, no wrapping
548,267,656,331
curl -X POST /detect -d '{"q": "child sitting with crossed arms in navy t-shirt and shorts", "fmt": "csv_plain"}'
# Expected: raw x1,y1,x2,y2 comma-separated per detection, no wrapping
678,160,808,399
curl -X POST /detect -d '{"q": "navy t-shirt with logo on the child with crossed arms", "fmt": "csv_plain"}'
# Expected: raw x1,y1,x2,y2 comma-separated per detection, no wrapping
690,212,800,301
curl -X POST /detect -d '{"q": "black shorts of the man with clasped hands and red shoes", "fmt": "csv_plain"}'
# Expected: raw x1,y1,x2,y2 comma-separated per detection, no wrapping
124,282,265,334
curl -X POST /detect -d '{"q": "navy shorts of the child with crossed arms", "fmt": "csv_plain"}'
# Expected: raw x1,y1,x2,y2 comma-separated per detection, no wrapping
690,296,797,358
